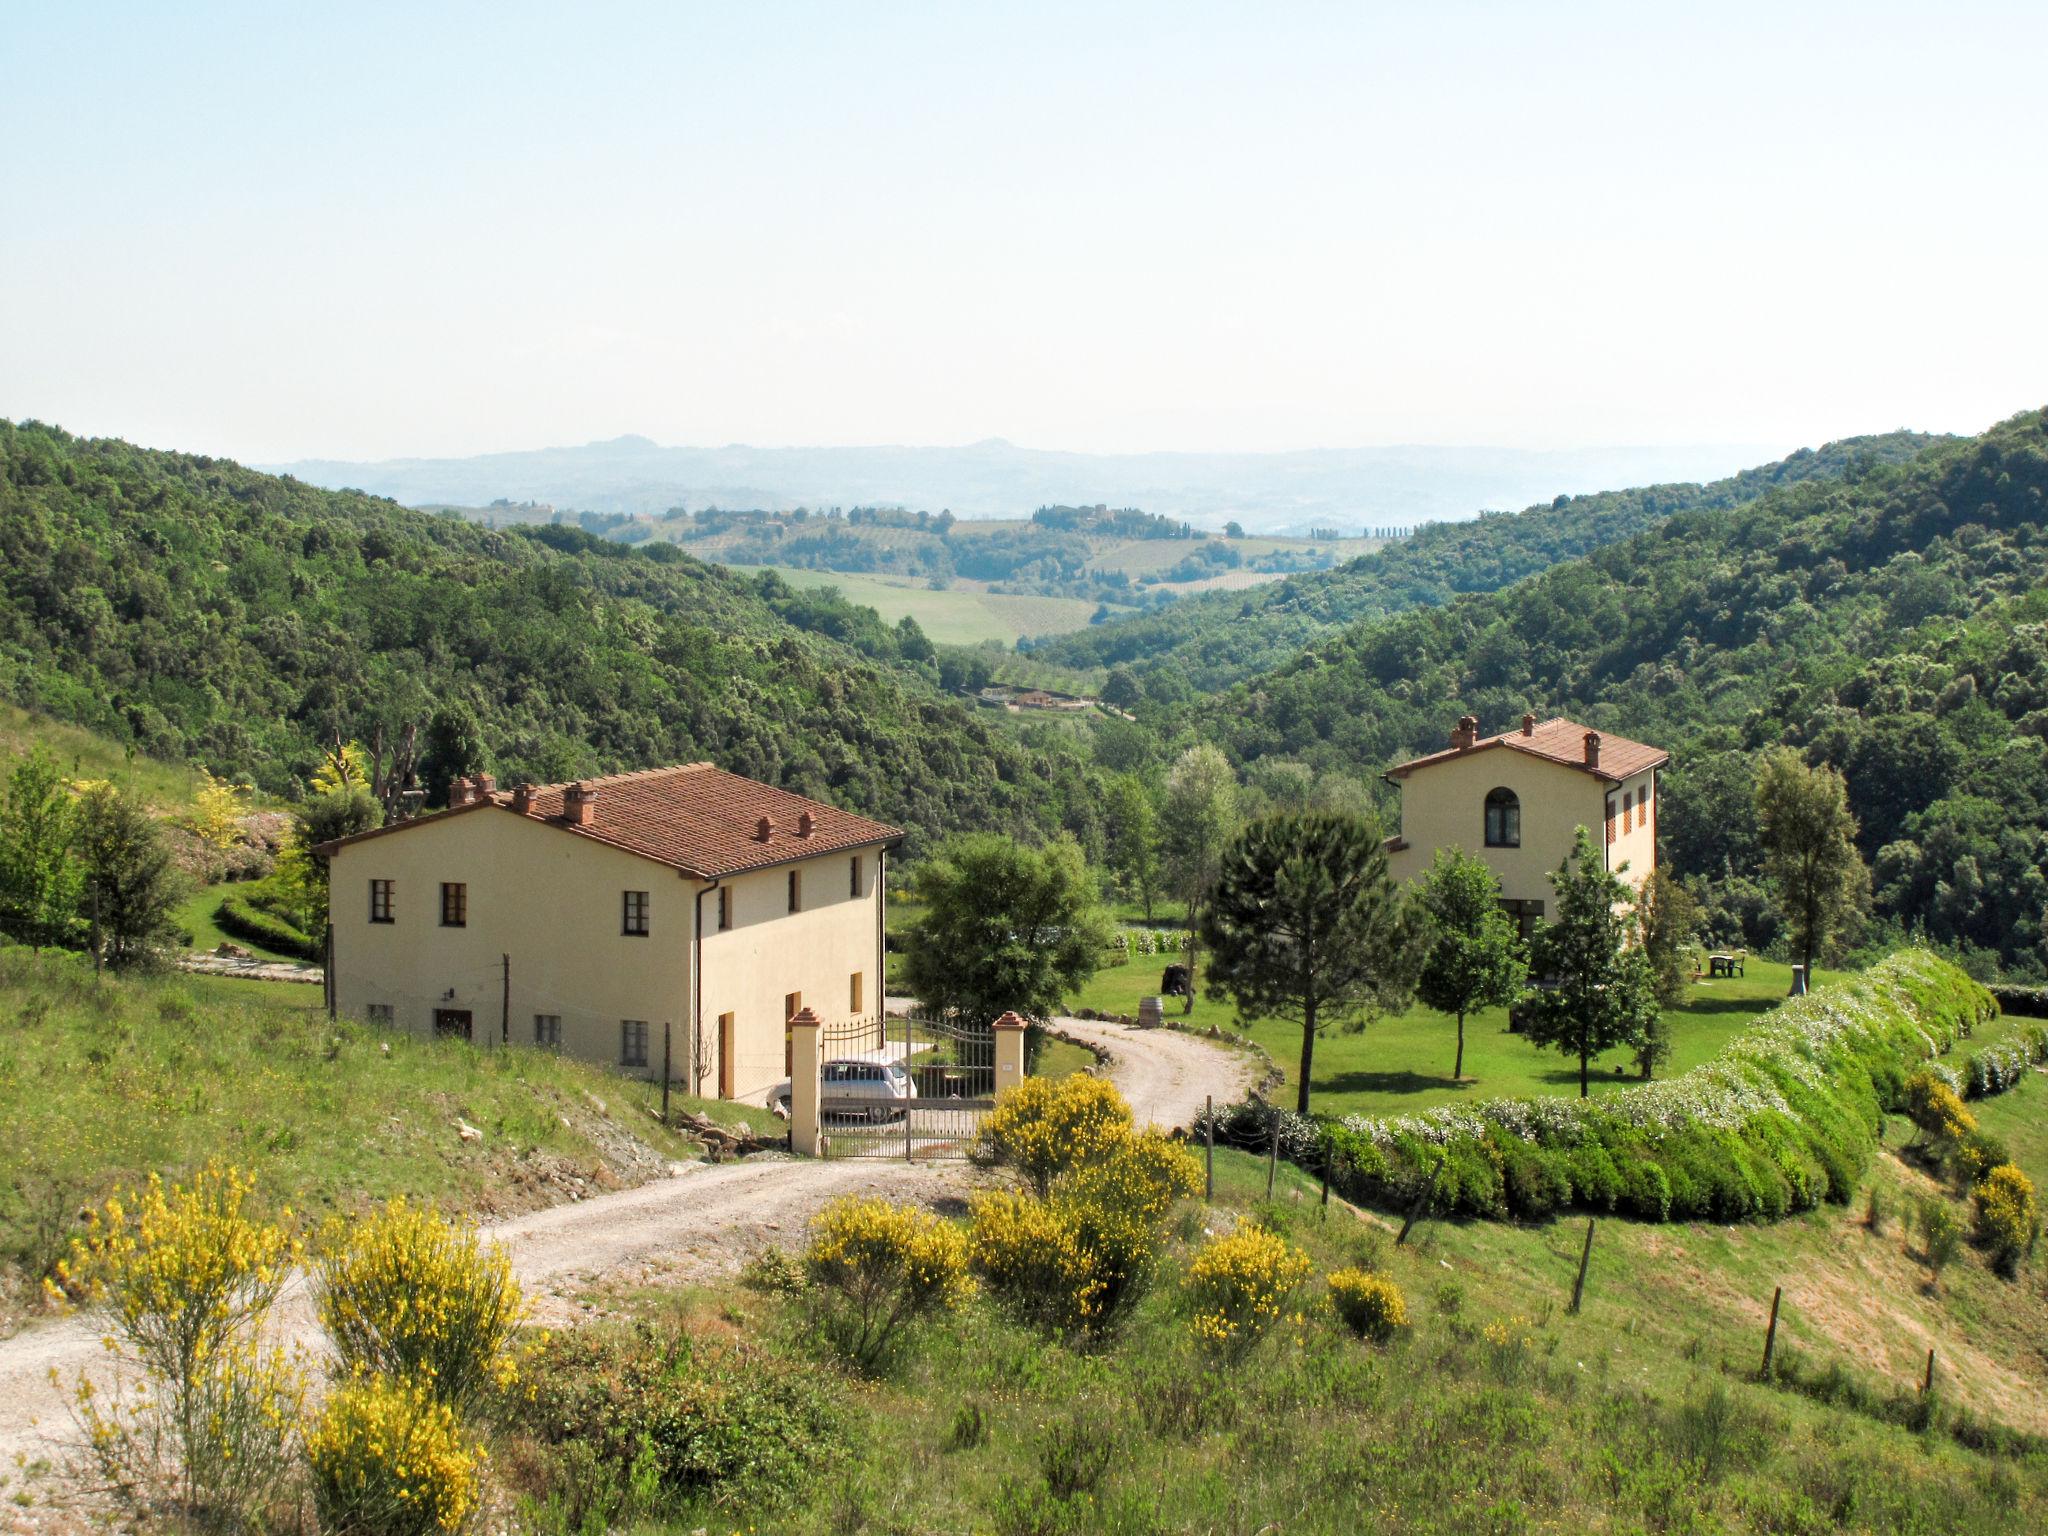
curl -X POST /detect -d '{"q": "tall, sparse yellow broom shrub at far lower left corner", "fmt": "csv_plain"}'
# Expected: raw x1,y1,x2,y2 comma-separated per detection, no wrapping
53,1163,305,1524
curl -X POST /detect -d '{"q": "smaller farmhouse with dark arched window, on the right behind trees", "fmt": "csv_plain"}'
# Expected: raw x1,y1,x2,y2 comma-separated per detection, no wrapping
1386,715,1671,934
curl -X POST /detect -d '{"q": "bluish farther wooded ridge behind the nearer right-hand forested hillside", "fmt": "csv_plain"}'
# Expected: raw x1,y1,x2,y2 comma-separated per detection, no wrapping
1032,432,1939,700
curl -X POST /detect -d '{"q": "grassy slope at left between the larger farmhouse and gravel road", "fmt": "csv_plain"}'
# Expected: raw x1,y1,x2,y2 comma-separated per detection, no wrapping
0,948,776,1313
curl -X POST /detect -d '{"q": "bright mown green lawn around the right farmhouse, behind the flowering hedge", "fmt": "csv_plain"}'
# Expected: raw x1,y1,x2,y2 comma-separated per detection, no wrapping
1071,954,1827,1114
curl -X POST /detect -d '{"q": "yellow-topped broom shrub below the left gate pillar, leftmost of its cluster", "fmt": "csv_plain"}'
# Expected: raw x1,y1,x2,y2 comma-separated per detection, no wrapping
803,1196,973,1370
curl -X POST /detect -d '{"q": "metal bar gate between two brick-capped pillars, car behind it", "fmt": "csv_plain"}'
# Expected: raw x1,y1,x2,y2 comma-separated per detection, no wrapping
817,1014,995,1159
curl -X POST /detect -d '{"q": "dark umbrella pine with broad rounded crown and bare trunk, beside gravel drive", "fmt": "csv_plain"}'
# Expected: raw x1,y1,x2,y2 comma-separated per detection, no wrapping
1202,813,1411,1114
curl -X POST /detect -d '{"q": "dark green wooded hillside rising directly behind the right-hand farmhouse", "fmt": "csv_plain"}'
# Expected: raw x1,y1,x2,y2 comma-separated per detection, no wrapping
1186,412,2048,973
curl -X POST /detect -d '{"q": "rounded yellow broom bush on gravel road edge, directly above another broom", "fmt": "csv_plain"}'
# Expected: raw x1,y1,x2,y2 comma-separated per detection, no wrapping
313,1198,526,1411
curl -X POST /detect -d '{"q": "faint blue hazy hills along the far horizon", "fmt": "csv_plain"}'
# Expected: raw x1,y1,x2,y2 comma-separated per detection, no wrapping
274,436,1767,532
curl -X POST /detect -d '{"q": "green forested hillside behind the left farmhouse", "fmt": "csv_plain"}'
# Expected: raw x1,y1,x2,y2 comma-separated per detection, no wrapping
0,422,1096,856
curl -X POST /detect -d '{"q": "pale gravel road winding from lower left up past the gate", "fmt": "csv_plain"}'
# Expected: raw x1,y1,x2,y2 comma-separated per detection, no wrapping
0,1020,1255,1491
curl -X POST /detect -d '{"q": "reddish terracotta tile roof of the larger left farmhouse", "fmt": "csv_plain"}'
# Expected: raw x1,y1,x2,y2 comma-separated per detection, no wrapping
324,762,903,879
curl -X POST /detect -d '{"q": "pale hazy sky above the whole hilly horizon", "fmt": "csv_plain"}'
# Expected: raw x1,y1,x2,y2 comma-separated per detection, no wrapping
0,0,2048,461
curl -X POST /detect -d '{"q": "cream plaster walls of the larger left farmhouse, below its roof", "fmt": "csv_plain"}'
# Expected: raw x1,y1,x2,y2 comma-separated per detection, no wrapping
328,807,883,1100
